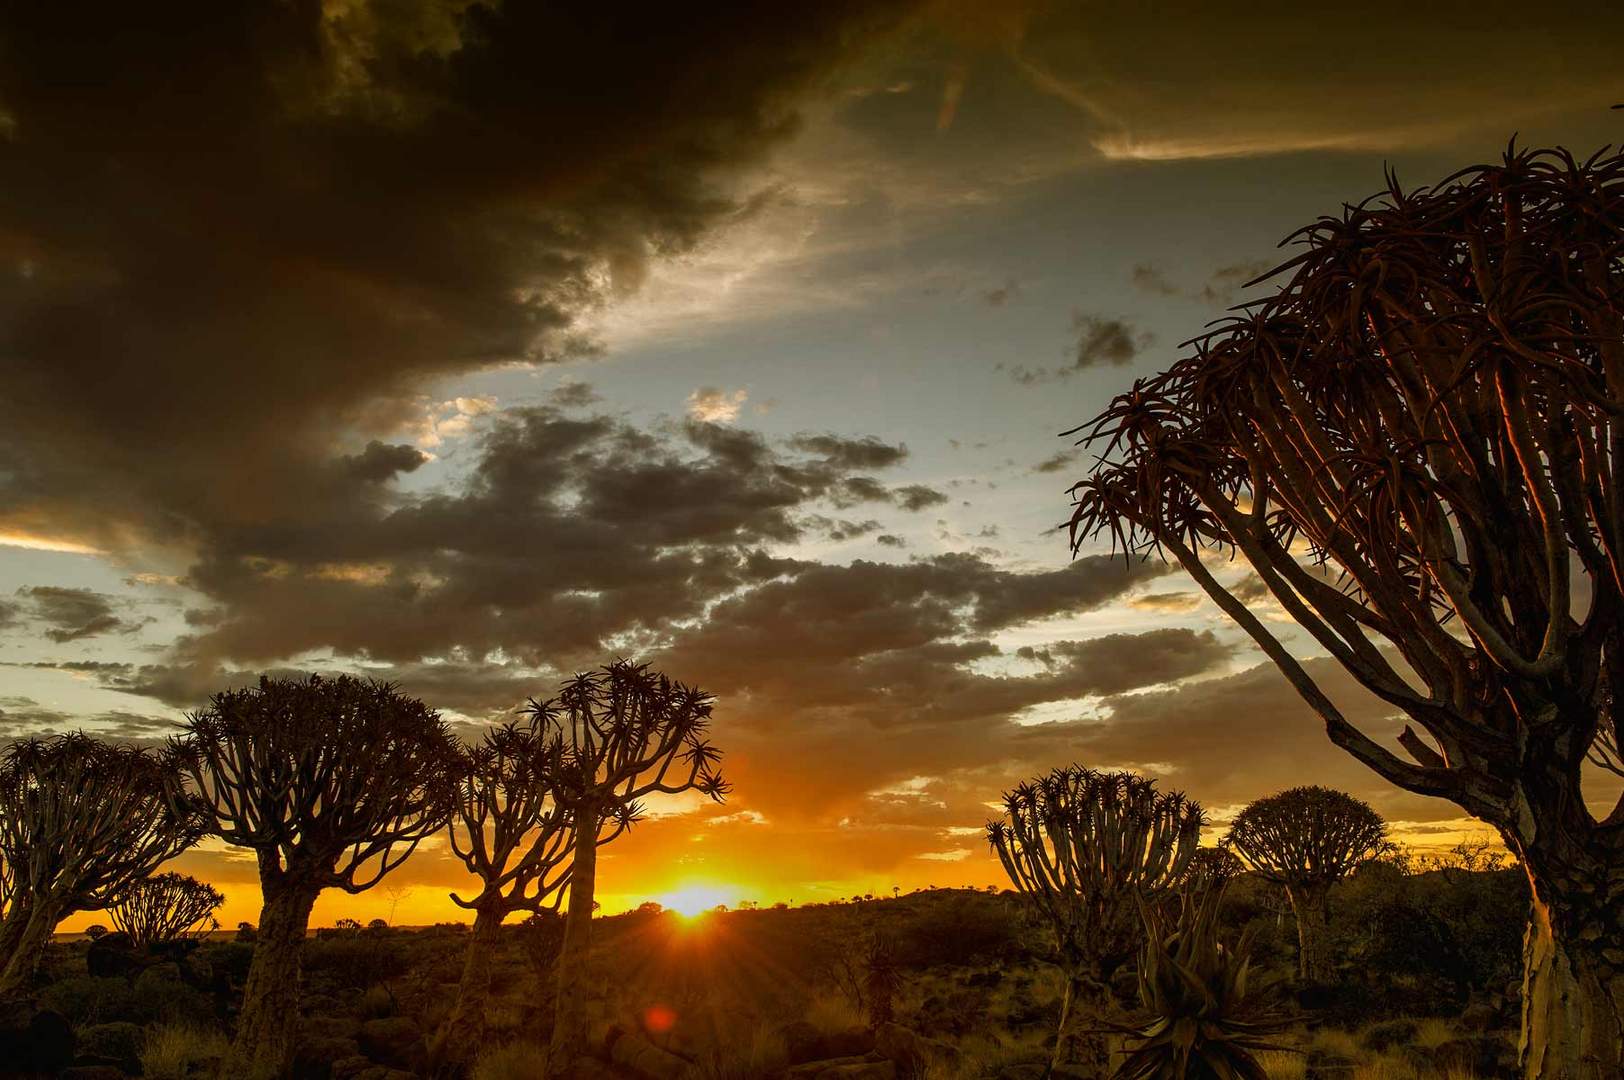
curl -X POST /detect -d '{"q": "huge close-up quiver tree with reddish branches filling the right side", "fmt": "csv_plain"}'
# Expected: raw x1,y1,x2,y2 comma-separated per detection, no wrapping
1070,149,1624,1078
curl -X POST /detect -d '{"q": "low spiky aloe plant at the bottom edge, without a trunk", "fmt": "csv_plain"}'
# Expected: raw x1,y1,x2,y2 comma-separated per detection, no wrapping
1116,885,1289,1080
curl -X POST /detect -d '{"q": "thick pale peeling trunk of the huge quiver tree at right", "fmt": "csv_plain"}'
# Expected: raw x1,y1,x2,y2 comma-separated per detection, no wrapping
1517,870,1624,1080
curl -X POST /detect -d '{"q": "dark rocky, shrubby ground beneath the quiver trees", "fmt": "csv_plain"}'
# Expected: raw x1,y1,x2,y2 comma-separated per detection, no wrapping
0,867,1525,1080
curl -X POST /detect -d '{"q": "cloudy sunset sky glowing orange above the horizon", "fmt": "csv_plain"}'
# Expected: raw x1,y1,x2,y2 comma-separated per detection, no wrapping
0,0,1624,929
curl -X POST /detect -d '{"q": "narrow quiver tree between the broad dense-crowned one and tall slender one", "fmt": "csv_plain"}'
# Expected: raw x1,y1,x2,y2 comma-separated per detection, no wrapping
435,723,573,1065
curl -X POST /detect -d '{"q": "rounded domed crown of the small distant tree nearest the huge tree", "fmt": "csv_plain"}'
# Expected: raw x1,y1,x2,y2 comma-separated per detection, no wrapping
1224,788,1387,887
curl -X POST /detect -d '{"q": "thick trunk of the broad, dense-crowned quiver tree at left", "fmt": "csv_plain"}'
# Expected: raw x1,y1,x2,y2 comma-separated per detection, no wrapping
224,887,318,1077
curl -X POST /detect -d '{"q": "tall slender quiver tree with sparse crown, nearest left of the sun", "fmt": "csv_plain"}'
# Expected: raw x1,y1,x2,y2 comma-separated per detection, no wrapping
528,659,728,1067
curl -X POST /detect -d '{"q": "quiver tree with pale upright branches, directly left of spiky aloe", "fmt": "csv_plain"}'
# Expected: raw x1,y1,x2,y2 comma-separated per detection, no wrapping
987,765,1202,1075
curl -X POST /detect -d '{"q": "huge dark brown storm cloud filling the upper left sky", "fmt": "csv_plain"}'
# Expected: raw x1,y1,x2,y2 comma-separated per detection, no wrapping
0,2,915,546
